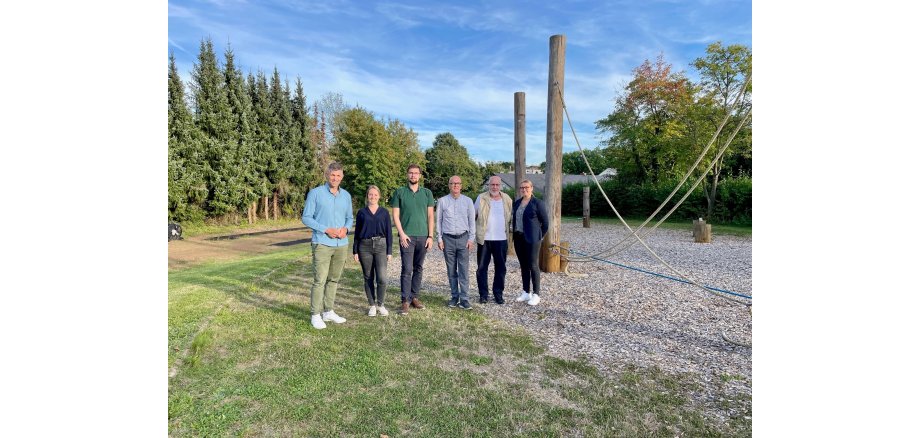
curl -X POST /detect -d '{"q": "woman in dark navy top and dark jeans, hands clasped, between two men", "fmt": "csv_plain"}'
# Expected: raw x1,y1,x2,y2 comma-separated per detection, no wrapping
352,185,393,316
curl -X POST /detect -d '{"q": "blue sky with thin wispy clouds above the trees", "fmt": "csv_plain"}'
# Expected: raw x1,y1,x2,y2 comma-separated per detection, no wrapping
168,0,752,164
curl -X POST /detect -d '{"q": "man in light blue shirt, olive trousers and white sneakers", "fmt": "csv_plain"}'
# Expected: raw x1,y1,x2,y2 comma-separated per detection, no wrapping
300,162,354,330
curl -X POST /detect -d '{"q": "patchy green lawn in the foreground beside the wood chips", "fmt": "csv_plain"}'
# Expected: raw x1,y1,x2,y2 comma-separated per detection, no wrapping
168,245,751,437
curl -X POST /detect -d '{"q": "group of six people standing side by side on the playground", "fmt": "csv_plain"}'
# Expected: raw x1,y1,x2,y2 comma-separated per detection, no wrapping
301,163,549,329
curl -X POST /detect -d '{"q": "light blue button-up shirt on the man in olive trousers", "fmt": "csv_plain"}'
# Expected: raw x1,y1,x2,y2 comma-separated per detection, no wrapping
300,183,354,247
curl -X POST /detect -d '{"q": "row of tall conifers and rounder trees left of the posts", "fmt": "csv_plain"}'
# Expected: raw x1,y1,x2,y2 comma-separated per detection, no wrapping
168,39,503,223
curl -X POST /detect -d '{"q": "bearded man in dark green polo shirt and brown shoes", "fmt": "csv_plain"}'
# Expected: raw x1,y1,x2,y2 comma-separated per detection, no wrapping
390,164,434,315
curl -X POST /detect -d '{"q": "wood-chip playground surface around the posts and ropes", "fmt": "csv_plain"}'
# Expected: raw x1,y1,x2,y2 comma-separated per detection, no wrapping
380,223,753,421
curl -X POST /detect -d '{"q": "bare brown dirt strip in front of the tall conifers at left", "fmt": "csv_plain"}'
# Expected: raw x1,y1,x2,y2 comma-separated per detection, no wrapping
169,227,311,269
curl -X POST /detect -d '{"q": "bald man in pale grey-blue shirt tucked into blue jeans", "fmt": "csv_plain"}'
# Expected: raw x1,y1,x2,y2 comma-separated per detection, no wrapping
437,175,476,310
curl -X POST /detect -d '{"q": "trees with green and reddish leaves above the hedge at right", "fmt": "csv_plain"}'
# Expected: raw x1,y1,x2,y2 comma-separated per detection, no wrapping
597,42,752,221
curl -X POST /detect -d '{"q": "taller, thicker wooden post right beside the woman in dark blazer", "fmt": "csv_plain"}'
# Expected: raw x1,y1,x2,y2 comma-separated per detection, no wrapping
540,35,565,272
